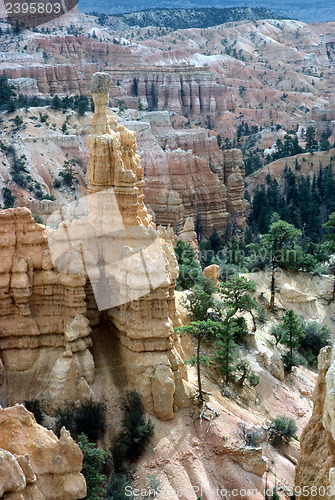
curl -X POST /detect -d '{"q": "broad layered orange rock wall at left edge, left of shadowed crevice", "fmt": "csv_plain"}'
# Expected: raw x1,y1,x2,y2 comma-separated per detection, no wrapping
0,208,93,409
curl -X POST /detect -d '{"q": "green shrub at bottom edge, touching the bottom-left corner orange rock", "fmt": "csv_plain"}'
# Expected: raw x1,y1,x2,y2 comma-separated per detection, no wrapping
77,434,107,500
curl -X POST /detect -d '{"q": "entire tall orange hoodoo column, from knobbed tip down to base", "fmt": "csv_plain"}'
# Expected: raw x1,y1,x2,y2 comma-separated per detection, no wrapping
87,73,192,419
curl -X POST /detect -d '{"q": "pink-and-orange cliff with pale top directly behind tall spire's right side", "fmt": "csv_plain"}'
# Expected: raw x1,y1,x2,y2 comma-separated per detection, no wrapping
126,112,249,238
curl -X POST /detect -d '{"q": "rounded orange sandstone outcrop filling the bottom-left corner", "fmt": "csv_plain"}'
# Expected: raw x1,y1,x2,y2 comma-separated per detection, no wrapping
0,405,86,500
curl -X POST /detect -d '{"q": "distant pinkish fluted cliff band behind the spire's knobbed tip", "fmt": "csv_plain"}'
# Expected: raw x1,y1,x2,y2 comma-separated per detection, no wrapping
0,35,230,117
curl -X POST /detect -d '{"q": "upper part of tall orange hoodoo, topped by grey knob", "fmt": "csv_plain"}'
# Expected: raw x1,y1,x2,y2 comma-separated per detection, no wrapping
86,73,154,227
